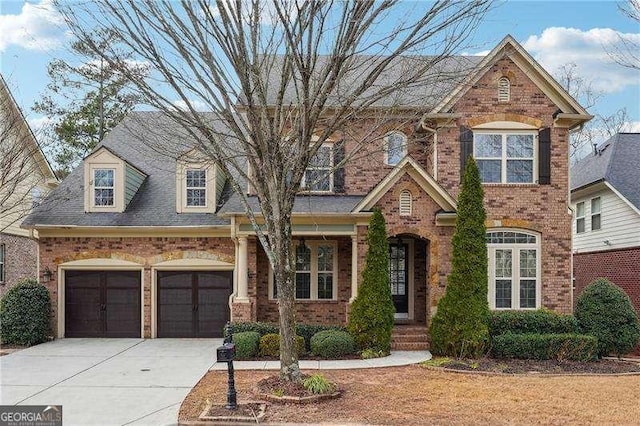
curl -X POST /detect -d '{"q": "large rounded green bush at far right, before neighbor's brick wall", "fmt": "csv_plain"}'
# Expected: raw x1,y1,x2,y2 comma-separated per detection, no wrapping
575,278,640,357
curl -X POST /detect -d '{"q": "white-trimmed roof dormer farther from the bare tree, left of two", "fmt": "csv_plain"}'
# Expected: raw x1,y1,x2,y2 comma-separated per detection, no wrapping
84,147,147,213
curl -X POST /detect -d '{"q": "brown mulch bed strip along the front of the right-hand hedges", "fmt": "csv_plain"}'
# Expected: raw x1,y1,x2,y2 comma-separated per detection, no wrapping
425,358,640,374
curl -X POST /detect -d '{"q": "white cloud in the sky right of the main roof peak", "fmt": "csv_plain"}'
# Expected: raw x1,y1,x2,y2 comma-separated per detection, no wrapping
523,27,640,93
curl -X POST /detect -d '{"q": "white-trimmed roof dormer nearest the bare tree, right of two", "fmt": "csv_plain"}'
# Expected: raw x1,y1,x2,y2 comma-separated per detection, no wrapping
176,150,225,213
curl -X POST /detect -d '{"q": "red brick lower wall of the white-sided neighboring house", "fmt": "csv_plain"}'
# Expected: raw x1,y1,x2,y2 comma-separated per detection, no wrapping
573,247,640,313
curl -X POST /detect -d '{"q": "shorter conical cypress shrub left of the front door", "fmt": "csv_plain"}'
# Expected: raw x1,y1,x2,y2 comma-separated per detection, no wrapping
347,209,395,353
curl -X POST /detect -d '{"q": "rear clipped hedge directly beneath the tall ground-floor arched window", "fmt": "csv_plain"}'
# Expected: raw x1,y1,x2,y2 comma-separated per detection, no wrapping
489,309,578,337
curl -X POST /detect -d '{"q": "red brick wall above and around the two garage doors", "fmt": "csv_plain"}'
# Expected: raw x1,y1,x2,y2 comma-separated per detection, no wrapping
40,237,235,337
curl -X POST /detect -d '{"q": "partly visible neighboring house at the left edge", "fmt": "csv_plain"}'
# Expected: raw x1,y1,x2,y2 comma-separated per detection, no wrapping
0,76,58,294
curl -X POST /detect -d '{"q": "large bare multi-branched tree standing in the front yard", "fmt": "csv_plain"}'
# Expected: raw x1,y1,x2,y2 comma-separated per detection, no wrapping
58,0,490,381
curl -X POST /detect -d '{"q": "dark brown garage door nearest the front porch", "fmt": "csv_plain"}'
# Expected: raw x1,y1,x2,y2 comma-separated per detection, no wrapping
158,271,233,337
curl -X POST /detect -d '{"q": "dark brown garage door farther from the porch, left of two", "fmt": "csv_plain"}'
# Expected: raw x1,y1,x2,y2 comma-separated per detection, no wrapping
64,271,140,337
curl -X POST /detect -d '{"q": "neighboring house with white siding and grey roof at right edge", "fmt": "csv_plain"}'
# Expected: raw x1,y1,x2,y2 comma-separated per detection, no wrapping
571,133,640,312
